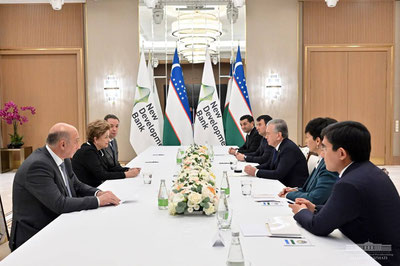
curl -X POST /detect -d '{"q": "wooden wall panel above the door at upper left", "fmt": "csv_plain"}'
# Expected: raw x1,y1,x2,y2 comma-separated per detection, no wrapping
0,4,83,49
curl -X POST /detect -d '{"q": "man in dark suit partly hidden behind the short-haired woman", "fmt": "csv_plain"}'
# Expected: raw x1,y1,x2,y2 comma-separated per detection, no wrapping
101,114,129,172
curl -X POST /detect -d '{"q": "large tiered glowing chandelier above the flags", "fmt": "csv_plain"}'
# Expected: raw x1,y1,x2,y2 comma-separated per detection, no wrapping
172,11,222,63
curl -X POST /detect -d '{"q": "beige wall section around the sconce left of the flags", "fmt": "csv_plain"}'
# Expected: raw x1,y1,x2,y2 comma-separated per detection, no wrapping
86,0,139,161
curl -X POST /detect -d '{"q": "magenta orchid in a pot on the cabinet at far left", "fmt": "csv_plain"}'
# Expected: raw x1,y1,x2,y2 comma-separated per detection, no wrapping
0,101,36,148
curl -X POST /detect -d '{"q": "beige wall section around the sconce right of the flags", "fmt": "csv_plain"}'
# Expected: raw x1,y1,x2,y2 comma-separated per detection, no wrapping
246,0,301,142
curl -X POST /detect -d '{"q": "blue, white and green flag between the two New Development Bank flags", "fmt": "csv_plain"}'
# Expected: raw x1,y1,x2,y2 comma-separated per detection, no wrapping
163,49,193,145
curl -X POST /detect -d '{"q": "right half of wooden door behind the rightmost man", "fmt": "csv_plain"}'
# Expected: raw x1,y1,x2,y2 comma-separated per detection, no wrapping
348,52,387,161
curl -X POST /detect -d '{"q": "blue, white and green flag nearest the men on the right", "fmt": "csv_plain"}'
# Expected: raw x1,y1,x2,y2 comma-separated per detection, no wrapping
225,47,253,147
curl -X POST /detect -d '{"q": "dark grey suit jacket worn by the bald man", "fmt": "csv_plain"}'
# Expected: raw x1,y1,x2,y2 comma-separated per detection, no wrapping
9,147,99,250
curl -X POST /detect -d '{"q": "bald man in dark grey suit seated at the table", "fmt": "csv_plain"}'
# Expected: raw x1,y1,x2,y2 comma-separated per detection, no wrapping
9,123,120,250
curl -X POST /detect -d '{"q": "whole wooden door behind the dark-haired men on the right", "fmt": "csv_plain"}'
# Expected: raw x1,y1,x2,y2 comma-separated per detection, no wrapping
303,46,393,165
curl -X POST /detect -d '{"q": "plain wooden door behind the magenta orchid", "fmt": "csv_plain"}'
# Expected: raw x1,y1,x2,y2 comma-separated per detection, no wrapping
0,54,79,149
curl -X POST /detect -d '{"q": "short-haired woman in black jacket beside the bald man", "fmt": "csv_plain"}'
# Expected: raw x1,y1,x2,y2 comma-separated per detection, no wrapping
72,120,140,187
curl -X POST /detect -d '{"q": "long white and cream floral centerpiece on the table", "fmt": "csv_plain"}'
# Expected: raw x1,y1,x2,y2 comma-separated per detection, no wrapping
168,145,218,215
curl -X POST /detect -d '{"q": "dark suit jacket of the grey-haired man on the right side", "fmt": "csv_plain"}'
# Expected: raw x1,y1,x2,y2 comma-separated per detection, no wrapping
257,138,308,187
